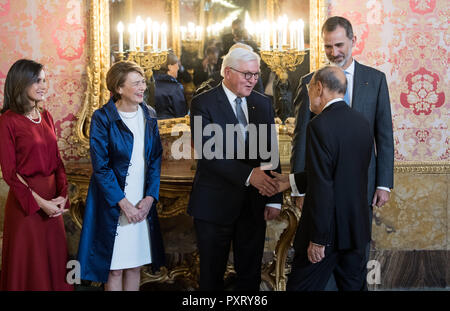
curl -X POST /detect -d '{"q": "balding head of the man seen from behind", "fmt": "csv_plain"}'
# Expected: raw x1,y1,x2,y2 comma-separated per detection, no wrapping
311,65,347,97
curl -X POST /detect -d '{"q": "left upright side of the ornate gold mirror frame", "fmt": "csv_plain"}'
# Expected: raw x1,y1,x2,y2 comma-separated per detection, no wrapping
71,0,110,158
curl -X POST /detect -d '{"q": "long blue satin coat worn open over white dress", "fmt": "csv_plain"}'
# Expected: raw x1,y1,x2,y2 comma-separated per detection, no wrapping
78,99,165,283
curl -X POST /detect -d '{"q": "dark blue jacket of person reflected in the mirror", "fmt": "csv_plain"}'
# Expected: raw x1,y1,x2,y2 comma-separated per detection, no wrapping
155,74,188,119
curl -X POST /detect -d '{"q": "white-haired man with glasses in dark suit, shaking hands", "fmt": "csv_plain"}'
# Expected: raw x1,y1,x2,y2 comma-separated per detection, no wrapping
188,48,282,290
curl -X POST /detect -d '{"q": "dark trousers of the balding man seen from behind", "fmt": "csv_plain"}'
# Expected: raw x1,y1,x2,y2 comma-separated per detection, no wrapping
286,247,367,291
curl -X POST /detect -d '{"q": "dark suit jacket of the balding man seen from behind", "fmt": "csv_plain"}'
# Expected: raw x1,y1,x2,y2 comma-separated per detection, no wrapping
294,101,373,250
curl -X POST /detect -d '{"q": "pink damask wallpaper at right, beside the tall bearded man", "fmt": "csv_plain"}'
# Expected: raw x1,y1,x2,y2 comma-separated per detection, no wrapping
329,0,450,162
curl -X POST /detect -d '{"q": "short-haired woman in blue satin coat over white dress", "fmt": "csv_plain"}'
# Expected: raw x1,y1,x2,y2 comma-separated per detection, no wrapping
78,61,165,291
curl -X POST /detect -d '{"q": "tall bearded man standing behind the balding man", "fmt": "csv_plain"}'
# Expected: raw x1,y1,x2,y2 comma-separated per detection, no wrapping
291,16,394,288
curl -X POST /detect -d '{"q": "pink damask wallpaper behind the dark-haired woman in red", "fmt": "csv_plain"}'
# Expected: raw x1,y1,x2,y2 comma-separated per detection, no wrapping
0,0,88,160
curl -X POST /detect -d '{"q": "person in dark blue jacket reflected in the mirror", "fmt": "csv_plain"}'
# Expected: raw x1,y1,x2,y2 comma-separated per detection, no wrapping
154,52,188,119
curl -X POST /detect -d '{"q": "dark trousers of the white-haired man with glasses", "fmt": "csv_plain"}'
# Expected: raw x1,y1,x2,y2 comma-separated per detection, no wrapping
194,208,266,291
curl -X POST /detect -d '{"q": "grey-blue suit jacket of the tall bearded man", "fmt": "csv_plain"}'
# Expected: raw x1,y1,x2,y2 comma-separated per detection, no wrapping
291,60,394,205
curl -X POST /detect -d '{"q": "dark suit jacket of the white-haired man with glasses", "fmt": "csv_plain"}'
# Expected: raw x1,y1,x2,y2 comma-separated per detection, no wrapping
188,84,282,224
